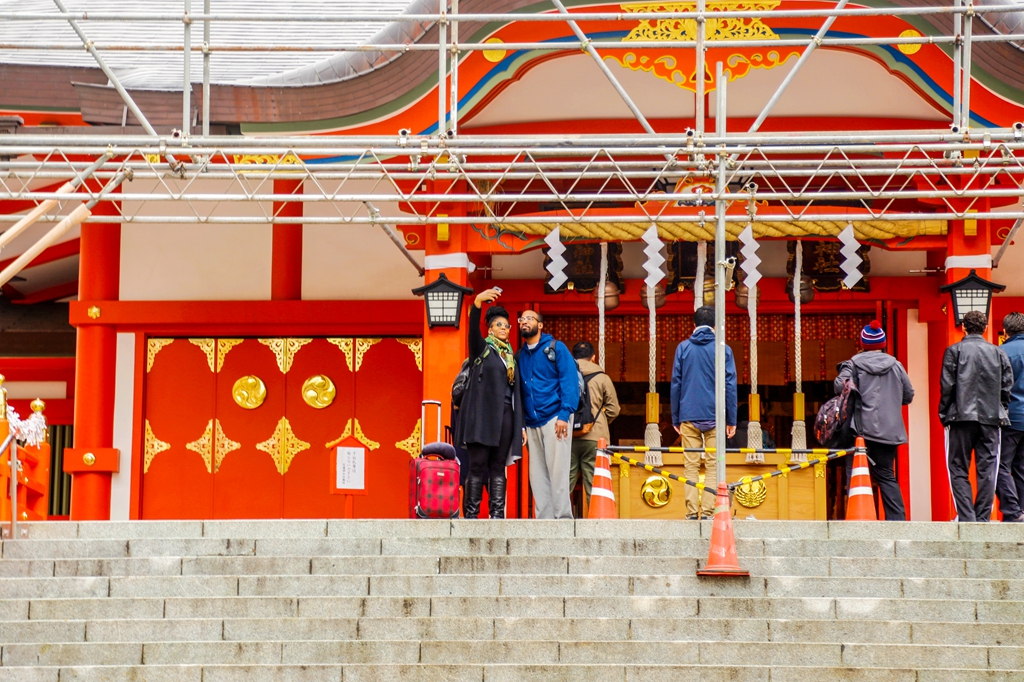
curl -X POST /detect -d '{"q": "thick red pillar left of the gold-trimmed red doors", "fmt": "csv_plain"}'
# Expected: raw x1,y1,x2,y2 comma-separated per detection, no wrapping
71,186,121,521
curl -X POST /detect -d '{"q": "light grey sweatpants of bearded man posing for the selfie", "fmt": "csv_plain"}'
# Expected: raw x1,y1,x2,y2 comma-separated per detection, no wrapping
526,416,572,518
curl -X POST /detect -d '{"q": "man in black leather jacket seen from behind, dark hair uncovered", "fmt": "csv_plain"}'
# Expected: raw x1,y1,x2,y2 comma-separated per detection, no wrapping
939,310,1014,521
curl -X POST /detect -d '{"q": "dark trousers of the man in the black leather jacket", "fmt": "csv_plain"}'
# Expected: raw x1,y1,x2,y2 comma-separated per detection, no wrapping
946,422,1000,521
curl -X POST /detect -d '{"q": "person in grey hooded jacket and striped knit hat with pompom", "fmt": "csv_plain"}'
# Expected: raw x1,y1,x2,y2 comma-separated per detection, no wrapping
835,319,913,521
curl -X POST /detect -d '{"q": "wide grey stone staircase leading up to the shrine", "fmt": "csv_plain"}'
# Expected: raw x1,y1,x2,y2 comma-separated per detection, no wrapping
0,520,1024,682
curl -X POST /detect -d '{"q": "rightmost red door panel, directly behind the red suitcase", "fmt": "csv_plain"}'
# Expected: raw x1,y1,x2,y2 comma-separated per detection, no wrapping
353,339,421,518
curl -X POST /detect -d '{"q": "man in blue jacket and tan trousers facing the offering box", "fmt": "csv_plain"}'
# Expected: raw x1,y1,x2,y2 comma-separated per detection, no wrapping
672,305,736,519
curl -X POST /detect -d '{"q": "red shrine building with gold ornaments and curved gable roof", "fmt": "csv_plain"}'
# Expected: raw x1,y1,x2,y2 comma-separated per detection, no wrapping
0,0,1024,520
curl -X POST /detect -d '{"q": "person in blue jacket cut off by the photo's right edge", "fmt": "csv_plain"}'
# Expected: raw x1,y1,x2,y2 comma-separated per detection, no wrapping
995,312,1024,522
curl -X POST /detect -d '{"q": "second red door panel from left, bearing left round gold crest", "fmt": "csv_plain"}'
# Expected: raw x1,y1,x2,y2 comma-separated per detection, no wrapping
213,339,286,518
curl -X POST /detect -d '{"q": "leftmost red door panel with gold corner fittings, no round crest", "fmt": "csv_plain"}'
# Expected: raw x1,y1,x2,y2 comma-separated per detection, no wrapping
140,339,215,519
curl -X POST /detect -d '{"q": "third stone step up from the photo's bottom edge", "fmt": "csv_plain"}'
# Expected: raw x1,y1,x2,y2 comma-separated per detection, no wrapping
0,615,1024,647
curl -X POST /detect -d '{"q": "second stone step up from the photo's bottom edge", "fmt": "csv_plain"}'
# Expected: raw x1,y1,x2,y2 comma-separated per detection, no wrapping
2,640,1024,671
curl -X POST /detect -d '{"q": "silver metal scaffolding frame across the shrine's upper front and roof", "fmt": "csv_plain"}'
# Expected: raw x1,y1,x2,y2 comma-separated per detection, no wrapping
0,0,1024,230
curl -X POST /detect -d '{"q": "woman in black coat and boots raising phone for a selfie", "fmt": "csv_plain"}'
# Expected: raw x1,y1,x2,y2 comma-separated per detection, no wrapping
456,289,522,518
